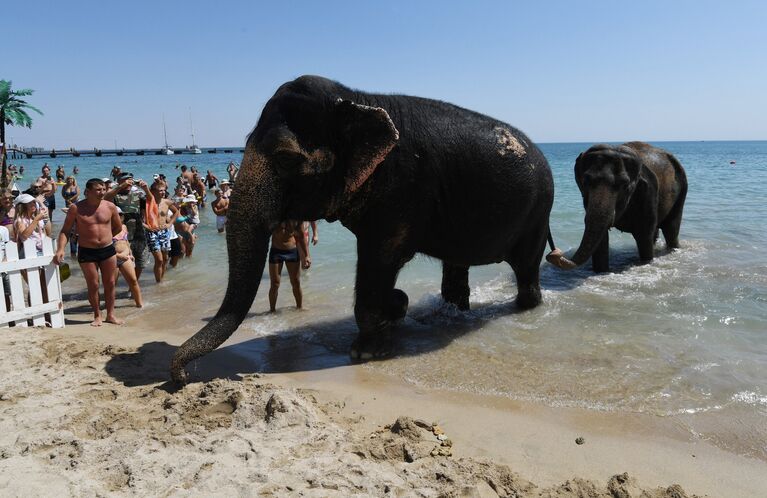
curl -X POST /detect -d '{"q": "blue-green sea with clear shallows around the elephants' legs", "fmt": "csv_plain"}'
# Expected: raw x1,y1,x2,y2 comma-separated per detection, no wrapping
14,142,767,459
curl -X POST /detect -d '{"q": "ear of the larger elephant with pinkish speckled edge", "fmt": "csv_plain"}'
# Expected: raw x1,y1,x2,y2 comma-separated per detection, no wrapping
334,99,399,198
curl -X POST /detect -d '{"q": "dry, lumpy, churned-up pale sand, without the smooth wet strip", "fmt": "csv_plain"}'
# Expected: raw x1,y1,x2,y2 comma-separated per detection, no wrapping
0,330,704,498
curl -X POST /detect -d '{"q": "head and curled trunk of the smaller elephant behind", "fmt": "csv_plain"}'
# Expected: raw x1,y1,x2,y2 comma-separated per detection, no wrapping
555,144,641,270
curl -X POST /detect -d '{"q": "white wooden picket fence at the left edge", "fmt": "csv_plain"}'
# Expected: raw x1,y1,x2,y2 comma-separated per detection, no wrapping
0,236,64,328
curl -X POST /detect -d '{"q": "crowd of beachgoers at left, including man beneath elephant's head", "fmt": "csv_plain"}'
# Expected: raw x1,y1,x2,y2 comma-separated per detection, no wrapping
0,162,319,326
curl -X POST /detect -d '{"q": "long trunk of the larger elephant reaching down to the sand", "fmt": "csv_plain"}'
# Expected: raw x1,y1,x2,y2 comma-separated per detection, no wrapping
171,156,277,384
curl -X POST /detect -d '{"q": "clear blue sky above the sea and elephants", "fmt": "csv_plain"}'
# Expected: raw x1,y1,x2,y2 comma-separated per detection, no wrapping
6,0,767,148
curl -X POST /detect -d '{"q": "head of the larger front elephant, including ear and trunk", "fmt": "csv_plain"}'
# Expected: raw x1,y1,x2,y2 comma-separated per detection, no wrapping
171,83,399,383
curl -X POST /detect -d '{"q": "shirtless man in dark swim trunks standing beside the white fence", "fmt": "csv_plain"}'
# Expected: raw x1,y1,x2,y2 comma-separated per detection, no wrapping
53,178,123,327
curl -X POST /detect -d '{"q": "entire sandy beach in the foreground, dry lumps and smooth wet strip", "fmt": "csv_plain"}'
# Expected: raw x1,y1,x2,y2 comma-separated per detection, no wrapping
0,288,767,497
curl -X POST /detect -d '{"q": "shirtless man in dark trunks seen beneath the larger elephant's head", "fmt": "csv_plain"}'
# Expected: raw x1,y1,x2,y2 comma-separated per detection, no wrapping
269,221,312,311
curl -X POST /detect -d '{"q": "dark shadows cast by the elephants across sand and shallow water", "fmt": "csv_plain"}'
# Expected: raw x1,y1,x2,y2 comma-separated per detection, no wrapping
106,248,664,390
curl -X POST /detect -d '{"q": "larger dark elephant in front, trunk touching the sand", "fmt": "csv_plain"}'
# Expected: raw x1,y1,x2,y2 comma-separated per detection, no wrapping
171,76,554,382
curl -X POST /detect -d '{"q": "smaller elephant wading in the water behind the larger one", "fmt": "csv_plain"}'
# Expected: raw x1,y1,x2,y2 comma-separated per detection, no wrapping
549,142,687,272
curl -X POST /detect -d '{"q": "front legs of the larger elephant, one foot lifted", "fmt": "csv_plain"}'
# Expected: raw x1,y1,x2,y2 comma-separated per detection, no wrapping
350,247,408,360
